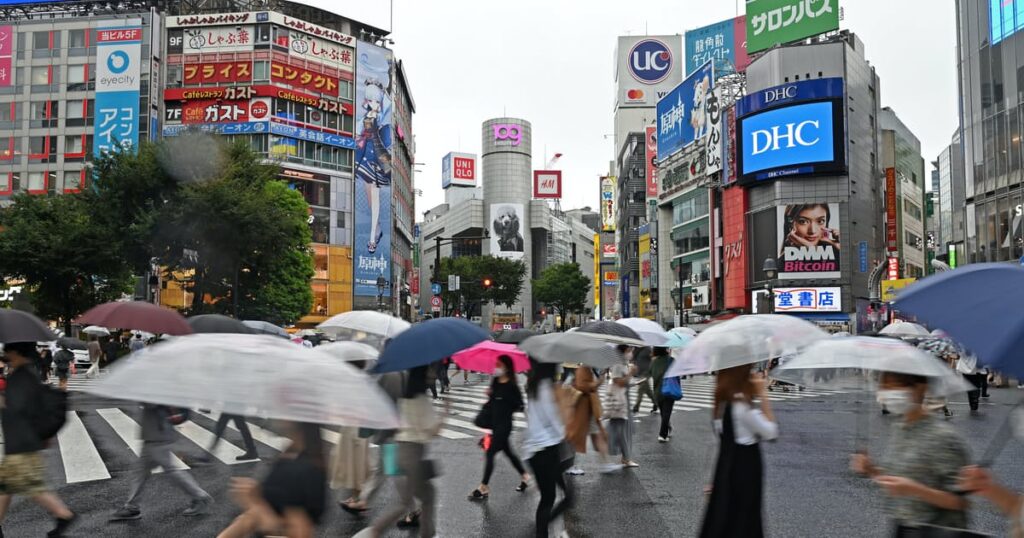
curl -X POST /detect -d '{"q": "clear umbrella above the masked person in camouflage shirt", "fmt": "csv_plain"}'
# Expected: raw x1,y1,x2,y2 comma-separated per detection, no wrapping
772,336,973,396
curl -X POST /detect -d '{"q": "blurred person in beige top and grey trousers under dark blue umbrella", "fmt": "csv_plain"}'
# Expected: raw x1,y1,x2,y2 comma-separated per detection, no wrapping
355,365,441,538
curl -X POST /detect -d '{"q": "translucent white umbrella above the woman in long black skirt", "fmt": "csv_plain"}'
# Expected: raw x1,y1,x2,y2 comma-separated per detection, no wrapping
666,314,828,376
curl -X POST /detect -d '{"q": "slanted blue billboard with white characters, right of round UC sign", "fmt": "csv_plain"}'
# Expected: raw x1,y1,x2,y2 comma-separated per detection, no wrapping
657,61,715,161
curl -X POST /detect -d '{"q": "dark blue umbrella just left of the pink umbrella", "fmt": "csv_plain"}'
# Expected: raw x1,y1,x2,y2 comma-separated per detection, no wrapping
374,318,489,374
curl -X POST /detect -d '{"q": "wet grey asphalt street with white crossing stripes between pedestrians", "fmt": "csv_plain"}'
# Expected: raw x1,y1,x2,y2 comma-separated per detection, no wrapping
4,376,1024,537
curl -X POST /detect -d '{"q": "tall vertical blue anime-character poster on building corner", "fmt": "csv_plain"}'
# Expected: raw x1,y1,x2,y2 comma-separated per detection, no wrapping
352,41,394,297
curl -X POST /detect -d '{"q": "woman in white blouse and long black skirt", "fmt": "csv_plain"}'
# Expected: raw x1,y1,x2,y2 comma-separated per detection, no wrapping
700,365,778,538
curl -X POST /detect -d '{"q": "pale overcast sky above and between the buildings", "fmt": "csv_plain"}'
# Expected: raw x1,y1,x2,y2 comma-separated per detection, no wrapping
300,0,958,213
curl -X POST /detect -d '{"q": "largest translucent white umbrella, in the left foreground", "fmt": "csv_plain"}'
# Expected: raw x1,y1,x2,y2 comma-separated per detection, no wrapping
87,334,398,429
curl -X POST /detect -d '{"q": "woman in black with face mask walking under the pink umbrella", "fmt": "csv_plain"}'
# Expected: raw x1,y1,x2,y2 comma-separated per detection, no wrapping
469,355,529,501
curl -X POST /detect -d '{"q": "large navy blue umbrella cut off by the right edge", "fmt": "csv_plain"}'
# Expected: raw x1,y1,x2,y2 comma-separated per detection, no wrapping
896,263,1024,375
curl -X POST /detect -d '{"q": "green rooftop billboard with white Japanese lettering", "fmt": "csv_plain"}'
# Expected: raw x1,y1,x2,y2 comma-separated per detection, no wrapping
746,0,839,53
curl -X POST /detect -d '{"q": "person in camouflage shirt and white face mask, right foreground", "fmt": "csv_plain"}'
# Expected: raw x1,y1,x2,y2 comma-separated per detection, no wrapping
850,372,968,537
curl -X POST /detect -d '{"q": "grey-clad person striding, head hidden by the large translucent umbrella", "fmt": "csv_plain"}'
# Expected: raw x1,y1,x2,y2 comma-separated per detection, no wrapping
111,404,213,522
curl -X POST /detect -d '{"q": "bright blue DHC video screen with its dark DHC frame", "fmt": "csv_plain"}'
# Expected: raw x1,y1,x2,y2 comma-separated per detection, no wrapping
736,78,846,182
